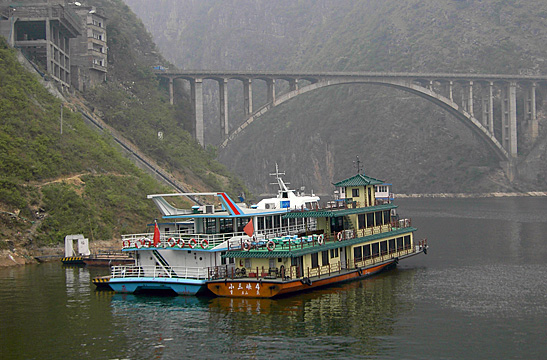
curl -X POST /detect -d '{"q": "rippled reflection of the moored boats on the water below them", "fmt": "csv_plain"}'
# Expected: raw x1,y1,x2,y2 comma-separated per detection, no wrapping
107,270,415,358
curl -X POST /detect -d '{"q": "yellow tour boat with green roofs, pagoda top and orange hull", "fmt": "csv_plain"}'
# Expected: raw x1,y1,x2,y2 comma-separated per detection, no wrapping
207,174,428,298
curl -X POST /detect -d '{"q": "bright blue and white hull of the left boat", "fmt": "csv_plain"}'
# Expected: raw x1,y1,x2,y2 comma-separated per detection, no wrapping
108,277,207,295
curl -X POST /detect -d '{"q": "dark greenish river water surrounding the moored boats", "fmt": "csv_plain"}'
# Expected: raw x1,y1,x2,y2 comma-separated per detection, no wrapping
0,198,547,359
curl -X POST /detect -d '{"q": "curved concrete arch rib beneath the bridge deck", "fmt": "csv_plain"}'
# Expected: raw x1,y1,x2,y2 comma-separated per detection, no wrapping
220,78,511,161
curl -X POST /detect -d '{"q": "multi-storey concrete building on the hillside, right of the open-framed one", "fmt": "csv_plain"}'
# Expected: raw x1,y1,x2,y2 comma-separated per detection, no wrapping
70,2,108,91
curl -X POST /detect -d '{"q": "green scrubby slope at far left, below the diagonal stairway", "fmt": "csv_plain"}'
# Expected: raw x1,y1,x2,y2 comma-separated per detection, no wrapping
0,37,173,247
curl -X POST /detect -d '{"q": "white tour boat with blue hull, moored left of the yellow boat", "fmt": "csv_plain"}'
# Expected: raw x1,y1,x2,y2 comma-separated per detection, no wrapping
107,192,310,295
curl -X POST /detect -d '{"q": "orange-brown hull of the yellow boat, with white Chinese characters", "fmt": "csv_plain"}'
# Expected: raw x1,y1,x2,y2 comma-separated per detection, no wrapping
207,260,397,298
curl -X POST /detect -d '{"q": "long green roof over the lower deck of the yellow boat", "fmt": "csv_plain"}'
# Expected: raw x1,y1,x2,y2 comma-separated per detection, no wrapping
222,227,418,259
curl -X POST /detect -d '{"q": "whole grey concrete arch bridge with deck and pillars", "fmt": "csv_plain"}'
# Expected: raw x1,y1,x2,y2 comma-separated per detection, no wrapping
156,71,547,176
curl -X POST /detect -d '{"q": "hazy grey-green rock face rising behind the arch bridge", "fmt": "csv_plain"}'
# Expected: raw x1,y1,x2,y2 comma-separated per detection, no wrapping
125,0,547,194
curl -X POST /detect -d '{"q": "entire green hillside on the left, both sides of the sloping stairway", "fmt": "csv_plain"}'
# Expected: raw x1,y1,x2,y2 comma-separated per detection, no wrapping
0,0,250,250
